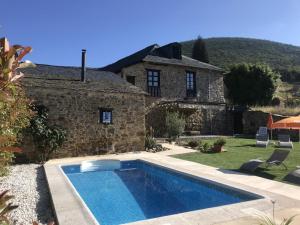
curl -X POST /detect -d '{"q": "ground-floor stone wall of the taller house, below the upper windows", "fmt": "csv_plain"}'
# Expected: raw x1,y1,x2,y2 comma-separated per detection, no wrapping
146,103,231,137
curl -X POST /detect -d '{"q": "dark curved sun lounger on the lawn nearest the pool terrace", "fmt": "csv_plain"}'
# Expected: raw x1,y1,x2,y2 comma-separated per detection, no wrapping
240,149,290,172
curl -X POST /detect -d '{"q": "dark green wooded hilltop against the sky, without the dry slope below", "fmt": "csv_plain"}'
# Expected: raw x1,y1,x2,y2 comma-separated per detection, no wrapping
182,38,300,72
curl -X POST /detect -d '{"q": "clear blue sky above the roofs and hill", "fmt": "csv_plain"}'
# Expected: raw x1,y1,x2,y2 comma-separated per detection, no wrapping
0,0,300,67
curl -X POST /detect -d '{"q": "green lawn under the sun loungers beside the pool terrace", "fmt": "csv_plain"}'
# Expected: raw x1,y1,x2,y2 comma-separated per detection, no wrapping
173,138,300,185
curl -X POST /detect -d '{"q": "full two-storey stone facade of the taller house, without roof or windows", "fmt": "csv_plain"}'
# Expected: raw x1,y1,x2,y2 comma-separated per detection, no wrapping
119,62,227,136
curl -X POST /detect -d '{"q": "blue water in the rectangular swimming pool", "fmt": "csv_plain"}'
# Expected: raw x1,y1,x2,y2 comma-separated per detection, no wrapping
62,160,260,225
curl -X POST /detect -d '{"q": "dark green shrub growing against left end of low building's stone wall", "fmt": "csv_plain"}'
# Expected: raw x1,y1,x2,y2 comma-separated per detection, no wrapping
26,105,66,161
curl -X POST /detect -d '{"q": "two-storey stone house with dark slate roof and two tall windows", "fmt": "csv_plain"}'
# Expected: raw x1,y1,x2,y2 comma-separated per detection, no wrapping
100,43,229,136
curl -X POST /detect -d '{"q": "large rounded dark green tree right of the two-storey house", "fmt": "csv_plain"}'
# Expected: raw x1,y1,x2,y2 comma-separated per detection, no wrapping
224,64,280,106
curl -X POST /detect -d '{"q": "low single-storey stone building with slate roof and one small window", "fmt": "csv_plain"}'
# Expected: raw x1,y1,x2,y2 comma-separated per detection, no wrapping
21,50,146,157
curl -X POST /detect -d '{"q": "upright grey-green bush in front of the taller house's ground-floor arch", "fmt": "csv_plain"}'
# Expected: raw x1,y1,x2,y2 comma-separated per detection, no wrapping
166,112,185,138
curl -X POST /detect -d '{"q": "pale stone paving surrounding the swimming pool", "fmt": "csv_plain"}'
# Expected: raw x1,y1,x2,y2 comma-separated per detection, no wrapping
44,144,300,225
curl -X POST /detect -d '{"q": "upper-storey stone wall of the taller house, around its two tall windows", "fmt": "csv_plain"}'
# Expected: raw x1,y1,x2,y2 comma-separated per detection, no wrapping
120,62,225,103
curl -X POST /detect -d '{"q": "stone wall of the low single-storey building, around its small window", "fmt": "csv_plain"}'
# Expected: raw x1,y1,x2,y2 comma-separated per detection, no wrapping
22,78,145,157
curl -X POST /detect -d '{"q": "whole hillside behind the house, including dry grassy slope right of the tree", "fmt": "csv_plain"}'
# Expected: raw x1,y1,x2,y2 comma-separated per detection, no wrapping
182,38,300,107
